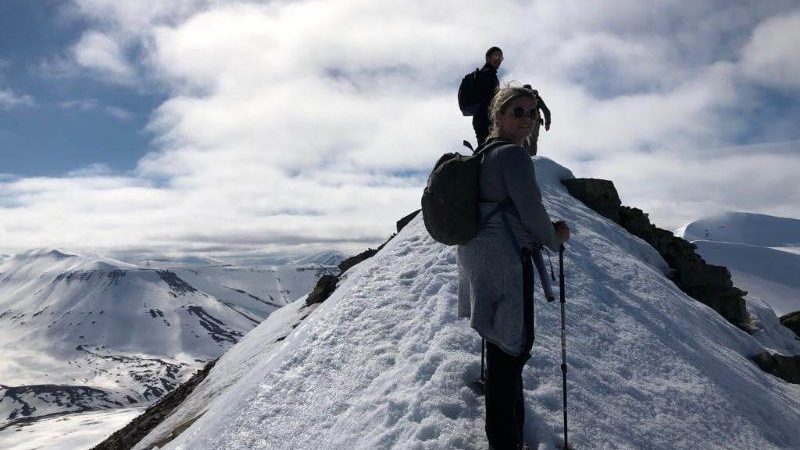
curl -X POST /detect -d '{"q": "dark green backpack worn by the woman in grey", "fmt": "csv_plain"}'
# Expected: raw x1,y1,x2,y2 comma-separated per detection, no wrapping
422,141,508,245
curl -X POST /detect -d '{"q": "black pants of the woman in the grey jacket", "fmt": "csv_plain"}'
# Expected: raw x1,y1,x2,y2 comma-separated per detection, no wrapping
486,249,533,450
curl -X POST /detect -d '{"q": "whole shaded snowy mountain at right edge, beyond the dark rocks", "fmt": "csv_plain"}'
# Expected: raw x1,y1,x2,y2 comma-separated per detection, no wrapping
675,212,800,316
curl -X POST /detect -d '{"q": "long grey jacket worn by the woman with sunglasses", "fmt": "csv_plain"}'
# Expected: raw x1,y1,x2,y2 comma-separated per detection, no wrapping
457,140,558,355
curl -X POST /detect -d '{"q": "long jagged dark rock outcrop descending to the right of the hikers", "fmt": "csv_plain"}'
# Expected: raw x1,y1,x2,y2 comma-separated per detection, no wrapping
563,178,750,331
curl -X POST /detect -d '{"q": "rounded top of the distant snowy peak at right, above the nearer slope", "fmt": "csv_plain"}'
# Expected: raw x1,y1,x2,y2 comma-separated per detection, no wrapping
674,212,800,247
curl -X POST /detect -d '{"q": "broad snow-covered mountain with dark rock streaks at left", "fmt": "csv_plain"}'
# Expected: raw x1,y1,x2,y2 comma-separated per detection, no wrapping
0,249,335,428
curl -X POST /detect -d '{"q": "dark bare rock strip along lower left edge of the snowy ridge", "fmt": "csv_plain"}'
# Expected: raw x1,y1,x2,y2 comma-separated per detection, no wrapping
92,360,217,450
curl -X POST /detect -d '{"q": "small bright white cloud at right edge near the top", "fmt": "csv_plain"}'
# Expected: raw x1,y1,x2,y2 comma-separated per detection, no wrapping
742,9,800,89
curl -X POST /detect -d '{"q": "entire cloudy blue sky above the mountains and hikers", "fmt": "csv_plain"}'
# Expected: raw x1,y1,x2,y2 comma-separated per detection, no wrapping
0,0,800,258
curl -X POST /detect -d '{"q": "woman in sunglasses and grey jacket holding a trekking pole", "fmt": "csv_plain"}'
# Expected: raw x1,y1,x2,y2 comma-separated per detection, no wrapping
458,87,569,450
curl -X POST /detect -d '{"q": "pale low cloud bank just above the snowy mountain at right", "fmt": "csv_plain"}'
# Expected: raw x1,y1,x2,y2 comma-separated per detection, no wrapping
576,141,800,230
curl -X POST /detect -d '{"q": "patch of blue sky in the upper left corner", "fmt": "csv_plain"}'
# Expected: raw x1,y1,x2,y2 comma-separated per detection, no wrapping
0,0,164,176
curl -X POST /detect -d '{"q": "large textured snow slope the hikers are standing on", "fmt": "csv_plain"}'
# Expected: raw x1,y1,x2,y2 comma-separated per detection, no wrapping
141,158,800,450
